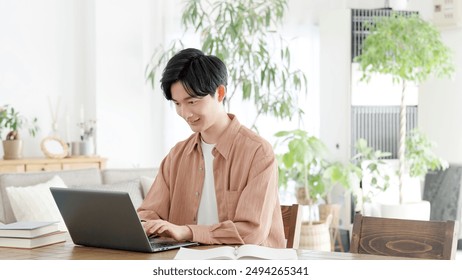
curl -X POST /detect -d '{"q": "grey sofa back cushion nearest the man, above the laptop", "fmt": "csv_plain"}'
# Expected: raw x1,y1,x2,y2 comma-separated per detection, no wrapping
101,168,157,184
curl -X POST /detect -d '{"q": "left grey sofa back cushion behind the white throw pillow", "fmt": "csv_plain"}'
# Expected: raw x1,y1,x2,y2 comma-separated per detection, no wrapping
0,168,102,224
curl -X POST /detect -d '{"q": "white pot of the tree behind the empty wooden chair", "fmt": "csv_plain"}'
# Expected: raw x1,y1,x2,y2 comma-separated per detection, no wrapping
380,200,430,221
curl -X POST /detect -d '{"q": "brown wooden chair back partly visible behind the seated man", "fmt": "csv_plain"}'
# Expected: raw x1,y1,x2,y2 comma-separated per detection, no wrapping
281,204,302,249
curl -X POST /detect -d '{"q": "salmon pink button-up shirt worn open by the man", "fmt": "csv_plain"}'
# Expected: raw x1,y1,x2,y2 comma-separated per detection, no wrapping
138,114,285,248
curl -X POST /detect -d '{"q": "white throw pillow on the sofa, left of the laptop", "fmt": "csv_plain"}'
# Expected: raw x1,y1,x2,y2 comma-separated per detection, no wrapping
6,175,66,230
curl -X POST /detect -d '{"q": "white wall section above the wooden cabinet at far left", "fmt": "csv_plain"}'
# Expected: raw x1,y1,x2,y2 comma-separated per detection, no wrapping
0,0,80,153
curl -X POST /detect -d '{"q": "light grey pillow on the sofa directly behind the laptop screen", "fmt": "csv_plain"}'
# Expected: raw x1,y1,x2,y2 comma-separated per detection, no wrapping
72,179,143,209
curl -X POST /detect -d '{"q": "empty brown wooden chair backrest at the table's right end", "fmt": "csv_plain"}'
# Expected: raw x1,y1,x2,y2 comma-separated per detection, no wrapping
350,214,458,260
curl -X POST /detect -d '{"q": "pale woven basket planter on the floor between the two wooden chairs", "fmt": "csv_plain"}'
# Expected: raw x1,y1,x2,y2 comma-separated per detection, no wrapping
299,216,332,251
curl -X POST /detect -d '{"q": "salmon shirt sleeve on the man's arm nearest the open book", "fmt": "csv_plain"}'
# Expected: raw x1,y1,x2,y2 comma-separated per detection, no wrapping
189,149,284,247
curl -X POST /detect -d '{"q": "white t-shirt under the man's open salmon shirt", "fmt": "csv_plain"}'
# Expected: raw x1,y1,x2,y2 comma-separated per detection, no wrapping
197,140,218,225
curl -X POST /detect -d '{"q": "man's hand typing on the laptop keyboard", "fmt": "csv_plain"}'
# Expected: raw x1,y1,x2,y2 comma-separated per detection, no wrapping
142,220,192,241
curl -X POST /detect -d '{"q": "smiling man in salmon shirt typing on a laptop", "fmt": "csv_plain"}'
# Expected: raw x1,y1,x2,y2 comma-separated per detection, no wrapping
138,49,285,248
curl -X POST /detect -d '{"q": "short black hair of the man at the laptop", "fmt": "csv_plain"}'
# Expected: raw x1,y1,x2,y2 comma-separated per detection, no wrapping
160,48,228,100
